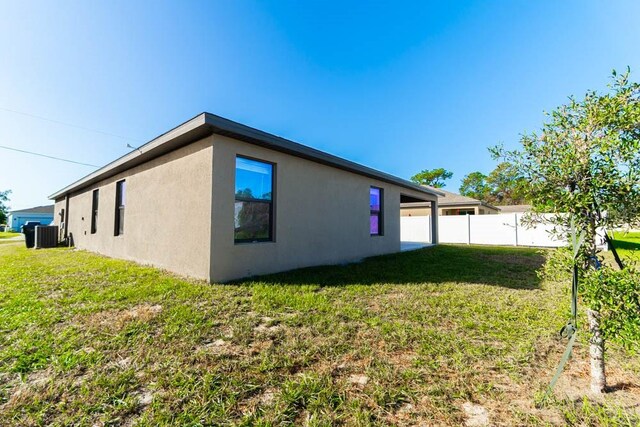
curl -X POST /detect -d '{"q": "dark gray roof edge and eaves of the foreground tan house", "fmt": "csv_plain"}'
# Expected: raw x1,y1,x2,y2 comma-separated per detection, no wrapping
49,113,443,199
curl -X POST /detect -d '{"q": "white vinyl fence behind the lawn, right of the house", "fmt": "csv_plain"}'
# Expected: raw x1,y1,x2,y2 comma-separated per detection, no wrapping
400,213,567,247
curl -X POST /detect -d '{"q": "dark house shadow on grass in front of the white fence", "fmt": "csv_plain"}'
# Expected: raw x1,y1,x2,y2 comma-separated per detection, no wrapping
234,245,544,289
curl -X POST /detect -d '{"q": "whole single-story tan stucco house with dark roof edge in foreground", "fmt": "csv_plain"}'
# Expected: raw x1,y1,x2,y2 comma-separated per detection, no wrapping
50,113,442,282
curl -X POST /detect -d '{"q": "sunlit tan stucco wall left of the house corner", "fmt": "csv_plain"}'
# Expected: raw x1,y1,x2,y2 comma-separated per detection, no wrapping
55,137,213,279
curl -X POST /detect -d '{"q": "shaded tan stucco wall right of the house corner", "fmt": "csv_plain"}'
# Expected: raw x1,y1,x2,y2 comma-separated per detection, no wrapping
211,135,436,281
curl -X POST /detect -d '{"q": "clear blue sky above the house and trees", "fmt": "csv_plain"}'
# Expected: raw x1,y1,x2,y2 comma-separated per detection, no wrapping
0,0,640,209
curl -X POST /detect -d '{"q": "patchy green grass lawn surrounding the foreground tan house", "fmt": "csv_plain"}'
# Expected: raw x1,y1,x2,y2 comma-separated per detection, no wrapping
0,243,640,426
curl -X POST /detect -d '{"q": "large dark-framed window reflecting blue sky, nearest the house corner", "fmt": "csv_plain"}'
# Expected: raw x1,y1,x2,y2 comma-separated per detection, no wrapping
234,156,273,243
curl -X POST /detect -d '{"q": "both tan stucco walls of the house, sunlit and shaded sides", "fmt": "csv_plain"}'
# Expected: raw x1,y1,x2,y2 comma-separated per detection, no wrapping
55,135,435,282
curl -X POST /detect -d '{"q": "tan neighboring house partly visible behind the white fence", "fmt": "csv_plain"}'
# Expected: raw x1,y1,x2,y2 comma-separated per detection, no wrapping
400,188,500,216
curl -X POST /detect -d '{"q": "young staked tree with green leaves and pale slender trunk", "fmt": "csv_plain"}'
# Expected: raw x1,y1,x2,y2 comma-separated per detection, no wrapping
492,70,640,393
